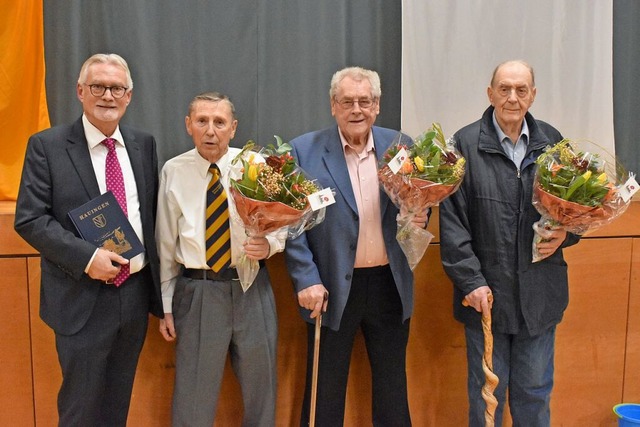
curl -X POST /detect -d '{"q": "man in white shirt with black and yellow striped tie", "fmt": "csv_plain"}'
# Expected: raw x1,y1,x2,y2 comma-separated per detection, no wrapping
156,92,286,427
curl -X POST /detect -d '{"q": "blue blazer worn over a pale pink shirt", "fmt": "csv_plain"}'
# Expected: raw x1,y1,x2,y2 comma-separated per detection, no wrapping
285,126,413,330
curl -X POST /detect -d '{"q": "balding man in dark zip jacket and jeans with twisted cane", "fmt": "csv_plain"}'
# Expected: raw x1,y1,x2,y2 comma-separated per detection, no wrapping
440,61,578,426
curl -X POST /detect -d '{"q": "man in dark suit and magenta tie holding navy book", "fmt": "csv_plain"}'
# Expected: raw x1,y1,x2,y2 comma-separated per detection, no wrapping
15,54,162,426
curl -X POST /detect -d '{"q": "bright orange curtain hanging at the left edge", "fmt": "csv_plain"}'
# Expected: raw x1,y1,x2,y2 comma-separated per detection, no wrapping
0,0,50,200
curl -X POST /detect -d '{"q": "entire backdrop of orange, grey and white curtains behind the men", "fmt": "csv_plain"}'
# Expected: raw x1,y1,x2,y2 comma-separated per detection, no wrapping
0,0,640,200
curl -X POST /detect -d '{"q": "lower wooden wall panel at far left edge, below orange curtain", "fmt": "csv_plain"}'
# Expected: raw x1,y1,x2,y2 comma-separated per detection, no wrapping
0,258,34,426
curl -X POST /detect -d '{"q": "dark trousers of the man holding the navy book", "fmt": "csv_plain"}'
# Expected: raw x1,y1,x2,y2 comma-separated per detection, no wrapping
56,268,151,427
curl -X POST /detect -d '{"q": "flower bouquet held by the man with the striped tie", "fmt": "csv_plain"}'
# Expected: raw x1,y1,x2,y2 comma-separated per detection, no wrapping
229,136,333,289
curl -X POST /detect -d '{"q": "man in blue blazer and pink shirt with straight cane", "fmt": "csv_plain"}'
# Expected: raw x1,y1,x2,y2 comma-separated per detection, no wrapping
285,67,427,427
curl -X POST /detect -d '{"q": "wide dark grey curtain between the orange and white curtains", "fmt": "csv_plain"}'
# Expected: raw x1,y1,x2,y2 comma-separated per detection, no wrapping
44,0,402,167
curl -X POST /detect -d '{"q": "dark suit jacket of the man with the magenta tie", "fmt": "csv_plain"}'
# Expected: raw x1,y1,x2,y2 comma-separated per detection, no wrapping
15,118,163,335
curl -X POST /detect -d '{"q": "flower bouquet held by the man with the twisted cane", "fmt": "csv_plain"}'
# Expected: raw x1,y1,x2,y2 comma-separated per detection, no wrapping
532,139,638,262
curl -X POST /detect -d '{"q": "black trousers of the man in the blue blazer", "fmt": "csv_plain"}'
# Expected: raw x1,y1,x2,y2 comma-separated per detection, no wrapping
300,266,411,427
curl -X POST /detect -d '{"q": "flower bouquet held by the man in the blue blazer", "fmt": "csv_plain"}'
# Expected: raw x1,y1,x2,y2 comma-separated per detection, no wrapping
378,123,465,270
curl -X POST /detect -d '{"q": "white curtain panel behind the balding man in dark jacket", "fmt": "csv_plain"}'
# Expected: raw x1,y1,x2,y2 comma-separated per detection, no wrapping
402,0,615,154
